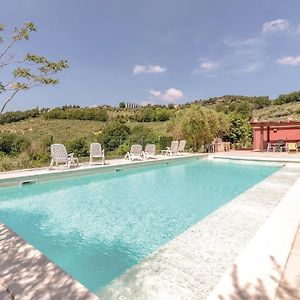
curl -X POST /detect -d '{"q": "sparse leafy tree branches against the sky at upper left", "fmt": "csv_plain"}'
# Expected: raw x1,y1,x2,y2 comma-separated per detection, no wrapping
0,22,68,115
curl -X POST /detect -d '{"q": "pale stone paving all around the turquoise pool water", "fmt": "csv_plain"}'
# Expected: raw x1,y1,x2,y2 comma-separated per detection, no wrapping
0,151,300,300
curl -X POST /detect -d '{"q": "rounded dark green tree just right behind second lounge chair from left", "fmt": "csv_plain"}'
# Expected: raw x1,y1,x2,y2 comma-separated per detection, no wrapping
99,121,130,151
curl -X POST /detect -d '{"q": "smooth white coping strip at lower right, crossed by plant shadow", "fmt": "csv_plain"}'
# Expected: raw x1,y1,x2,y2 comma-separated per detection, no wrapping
207,171,300,300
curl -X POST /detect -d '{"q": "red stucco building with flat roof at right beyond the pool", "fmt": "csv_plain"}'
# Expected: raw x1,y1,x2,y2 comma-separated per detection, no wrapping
251,121,300,151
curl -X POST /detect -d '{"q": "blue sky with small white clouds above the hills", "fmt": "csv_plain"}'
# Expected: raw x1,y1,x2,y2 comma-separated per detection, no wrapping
0,0,300,110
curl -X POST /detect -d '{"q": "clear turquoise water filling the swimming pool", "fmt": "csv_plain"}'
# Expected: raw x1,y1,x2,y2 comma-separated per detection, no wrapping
0,160,278,292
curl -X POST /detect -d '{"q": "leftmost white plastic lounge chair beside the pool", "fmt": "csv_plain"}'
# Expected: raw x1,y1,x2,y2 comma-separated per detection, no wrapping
49,144,78,169
